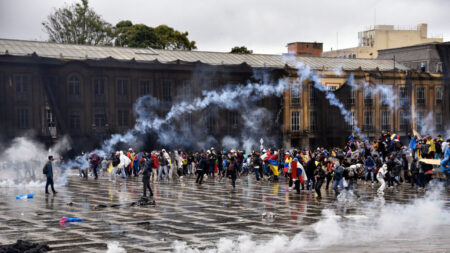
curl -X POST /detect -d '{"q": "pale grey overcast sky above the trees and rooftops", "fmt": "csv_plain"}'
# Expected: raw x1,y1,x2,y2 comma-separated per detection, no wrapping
0,0,450,54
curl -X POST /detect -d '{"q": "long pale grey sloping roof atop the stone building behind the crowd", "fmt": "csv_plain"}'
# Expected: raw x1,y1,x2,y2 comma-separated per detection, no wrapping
0,39,408,71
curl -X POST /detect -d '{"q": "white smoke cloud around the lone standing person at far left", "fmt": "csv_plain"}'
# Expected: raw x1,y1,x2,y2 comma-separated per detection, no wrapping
0,136,71,187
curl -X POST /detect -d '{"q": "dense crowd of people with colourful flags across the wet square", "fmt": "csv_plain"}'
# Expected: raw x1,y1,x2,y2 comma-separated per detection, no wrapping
46,132,450,199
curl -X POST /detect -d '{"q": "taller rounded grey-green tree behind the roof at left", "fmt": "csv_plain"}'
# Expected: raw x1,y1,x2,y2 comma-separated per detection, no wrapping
42,0,114,45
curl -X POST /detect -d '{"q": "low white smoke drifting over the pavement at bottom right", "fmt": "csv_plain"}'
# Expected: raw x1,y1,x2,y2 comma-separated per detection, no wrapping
172,183,450,253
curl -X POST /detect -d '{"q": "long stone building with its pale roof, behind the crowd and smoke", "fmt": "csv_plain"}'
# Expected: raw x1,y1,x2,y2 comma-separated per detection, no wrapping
0,39,445,150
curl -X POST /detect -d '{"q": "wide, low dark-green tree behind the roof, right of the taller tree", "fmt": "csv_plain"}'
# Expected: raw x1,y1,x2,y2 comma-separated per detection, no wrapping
114,20,197,50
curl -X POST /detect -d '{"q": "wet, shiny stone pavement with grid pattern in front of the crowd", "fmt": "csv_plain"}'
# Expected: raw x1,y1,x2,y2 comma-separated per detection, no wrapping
0,176,450,252
